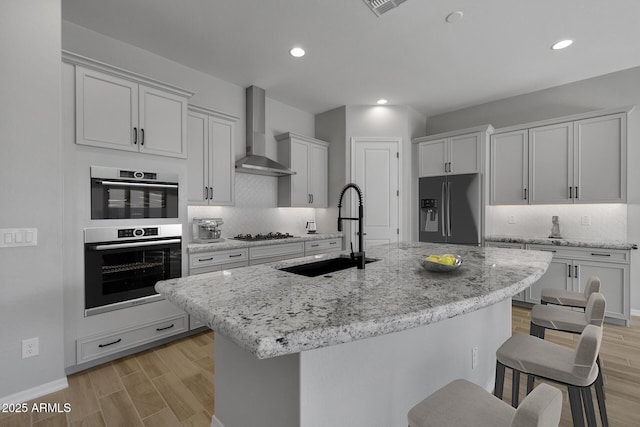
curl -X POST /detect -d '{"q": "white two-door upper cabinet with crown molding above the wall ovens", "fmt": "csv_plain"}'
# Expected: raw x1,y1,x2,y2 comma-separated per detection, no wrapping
68,52,192,158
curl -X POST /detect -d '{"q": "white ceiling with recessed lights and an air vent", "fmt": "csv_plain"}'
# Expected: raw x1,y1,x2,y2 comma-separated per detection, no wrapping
62,0,640,116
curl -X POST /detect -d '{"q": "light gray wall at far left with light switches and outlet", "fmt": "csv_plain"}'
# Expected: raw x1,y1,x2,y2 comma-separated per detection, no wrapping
0,0,65,401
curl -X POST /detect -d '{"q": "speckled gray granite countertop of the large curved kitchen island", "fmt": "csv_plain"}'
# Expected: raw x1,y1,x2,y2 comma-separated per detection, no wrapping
156,242,552,359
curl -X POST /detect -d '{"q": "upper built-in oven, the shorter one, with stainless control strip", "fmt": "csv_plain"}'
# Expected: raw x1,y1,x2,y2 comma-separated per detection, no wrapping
91,167,178,219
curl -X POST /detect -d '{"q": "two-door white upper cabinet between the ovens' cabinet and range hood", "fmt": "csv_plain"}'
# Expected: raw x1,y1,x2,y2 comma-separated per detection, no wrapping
187,106,238,205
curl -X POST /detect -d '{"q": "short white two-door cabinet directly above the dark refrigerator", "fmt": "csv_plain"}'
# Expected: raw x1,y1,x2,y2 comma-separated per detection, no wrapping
413,126,493,177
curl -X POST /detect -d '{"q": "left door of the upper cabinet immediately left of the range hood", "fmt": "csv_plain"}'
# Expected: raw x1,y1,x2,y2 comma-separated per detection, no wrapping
187,112,210,205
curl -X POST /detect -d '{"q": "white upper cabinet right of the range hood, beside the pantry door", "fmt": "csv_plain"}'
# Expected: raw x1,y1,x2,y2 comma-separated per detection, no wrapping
276,132,329,208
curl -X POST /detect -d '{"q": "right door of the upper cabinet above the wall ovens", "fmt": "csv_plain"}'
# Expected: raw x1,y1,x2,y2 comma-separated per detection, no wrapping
139,86,187,158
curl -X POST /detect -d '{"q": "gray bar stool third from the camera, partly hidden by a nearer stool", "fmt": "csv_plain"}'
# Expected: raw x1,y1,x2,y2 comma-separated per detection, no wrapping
527,292,609,427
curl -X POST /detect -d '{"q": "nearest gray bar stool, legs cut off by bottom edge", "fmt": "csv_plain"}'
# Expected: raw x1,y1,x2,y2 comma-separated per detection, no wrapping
407,379,562,427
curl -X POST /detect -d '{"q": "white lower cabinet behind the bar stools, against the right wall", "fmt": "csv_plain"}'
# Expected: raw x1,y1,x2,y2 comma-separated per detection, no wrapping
526,244,631,323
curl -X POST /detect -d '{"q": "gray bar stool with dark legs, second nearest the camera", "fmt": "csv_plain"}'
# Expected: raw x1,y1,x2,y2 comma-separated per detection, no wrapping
494,325,602,427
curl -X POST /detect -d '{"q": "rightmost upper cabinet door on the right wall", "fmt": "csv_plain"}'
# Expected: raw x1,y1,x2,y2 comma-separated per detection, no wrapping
574,114,627,203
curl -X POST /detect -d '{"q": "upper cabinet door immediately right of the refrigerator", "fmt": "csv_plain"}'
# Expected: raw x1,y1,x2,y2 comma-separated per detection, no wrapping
489,130,529,205
